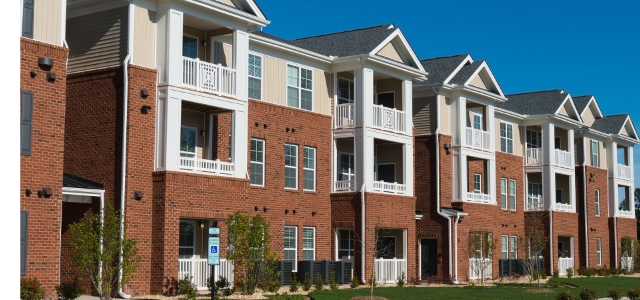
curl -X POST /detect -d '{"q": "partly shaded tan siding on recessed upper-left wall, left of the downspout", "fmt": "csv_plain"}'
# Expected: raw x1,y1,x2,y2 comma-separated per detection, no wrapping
66,6,129,73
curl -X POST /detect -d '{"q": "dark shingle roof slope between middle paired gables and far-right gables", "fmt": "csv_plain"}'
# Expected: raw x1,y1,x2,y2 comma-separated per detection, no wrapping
496,89,568,115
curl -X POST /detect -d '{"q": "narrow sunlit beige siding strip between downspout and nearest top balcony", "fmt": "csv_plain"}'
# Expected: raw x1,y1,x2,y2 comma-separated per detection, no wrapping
133,6,156,69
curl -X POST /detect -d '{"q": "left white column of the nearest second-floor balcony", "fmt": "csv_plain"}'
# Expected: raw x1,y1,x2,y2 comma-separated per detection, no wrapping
165,95,182,170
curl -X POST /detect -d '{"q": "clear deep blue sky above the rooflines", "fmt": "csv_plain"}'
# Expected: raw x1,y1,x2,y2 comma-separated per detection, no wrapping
256,0,640,183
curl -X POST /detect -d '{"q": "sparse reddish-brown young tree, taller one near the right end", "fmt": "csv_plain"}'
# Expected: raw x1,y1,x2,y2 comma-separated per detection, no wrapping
518,211,548,289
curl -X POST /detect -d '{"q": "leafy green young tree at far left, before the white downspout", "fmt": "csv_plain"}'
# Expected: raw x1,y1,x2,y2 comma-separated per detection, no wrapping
69,204,140,300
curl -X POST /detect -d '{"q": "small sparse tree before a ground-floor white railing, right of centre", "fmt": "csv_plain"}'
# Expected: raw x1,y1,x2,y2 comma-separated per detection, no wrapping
467,231,499,285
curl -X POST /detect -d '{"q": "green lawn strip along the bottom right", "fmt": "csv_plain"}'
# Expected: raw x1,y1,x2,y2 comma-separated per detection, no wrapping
309,277,640,300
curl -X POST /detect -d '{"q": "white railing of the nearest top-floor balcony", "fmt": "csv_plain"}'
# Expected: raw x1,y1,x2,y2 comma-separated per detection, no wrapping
182,57,236,97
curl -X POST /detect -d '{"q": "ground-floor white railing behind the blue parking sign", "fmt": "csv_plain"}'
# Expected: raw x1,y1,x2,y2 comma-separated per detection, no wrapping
178,258,233,290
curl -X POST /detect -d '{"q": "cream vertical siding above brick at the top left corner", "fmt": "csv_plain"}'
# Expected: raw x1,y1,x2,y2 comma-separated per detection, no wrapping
33,0,66,46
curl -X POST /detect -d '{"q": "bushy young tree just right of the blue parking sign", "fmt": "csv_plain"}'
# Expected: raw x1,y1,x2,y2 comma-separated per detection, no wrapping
227,212,279,295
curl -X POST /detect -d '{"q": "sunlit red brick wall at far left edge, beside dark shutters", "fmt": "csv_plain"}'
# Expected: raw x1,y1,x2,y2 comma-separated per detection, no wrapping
18,38,69,297
